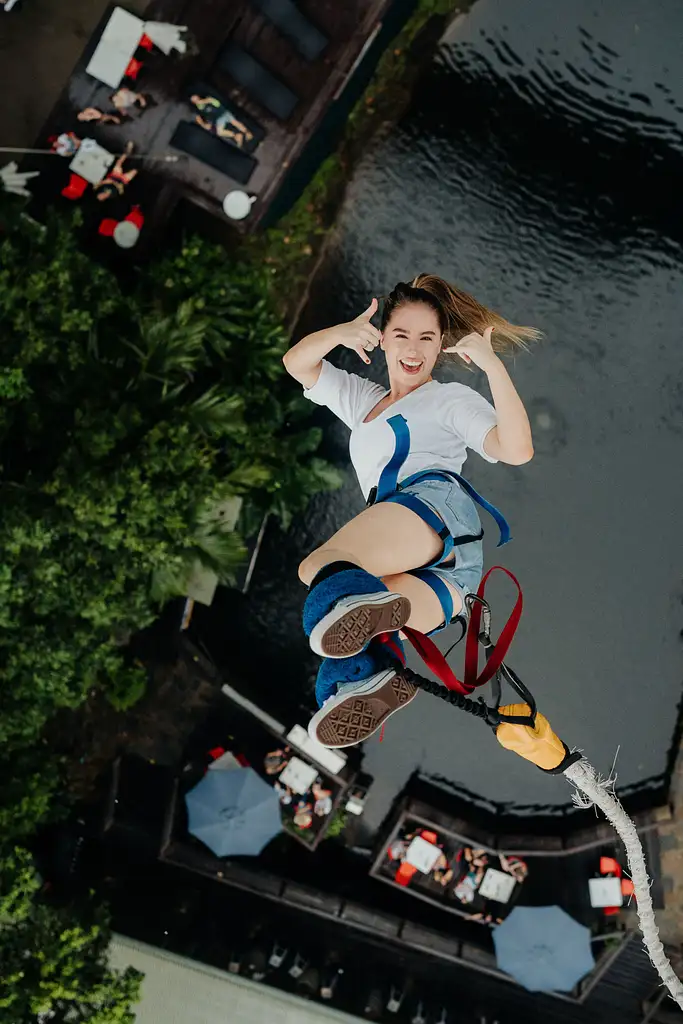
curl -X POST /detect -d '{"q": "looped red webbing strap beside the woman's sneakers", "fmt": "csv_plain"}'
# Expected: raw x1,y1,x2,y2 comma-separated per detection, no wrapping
402,565,523,696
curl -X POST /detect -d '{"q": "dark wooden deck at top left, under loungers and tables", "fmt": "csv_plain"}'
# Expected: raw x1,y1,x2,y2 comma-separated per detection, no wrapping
26,0,392,249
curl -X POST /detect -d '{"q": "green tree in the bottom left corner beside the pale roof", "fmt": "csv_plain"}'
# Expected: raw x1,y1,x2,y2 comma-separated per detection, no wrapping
0,847,142,1024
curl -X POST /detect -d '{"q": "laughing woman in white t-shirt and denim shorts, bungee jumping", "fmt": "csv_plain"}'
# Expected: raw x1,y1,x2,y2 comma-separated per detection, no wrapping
284,274,539,746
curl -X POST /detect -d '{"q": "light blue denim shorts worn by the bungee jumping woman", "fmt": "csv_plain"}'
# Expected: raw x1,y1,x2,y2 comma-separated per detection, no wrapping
401,480,483,606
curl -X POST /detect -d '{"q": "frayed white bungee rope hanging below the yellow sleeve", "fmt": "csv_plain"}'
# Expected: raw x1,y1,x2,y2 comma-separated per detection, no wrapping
564,759,683,1010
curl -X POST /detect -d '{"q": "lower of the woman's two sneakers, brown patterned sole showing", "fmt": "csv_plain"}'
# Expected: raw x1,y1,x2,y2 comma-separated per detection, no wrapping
308,669,418,748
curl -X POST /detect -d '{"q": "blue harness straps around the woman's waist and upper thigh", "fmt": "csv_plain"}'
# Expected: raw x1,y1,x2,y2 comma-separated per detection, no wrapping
368,415,510,548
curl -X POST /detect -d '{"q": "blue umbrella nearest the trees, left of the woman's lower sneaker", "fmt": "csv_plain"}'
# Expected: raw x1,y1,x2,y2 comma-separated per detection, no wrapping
185,768,283,857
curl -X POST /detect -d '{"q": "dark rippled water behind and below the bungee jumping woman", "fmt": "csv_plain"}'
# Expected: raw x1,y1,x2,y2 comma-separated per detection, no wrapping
231,0,683,820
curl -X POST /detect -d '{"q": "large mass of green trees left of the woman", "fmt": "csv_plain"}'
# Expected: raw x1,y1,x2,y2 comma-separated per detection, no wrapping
0,205,337,830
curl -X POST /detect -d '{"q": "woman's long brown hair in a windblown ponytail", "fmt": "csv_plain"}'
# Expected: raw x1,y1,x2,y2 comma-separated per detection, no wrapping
381,273,541,361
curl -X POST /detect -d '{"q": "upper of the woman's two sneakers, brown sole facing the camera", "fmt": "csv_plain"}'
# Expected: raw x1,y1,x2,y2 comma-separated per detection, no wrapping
308,592,411,657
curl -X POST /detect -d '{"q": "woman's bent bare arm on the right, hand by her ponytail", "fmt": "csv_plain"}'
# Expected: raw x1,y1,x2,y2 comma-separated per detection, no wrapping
443,328,533,466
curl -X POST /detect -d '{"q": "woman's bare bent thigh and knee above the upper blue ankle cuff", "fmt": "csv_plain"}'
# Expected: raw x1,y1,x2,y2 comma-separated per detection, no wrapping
299,502,443,584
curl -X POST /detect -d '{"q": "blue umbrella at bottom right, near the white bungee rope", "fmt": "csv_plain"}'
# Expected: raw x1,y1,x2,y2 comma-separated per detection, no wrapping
494,906,595,992
